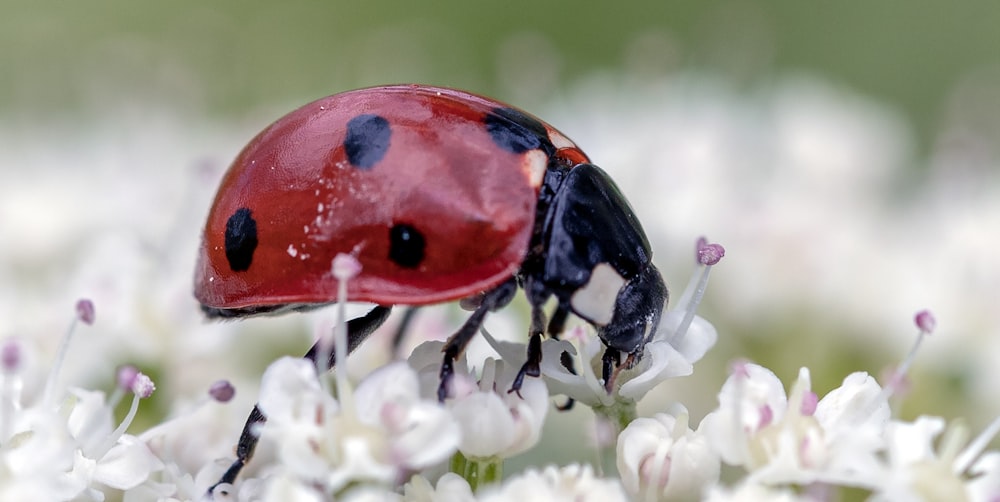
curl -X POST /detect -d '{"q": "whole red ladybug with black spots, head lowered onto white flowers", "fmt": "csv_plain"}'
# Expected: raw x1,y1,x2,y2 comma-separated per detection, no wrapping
195,85,667,488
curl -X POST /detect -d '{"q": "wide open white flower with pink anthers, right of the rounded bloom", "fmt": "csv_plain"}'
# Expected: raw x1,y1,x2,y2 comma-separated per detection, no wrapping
699,363,889,486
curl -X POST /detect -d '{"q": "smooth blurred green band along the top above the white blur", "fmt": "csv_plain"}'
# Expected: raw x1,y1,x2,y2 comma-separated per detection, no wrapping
7,0,1000,151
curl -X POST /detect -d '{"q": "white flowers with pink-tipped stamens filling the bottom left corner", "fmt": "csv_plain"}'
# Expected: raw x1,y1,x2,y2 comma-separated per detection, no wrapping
0,310,163,500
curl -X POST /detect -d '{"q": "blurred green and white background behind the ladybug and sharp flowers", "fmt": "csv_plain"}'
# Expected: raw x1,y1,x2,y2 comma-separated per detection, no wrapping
0,0,1000,476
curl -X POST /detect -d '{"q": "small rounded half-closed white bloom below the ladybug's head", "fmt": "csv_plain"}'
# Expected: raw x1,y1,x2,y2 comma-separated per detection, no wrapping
617,407,720,501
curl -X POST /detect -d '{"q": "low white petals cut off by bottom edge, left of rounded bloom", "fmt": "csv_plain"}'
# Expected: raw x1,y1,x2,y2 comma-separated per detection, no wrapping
478,464,629,502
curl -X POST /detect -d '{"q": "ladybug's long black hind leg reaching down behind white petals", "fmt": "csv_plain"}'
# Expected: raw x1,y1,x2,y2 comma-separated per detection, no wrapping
208,305,392,498
